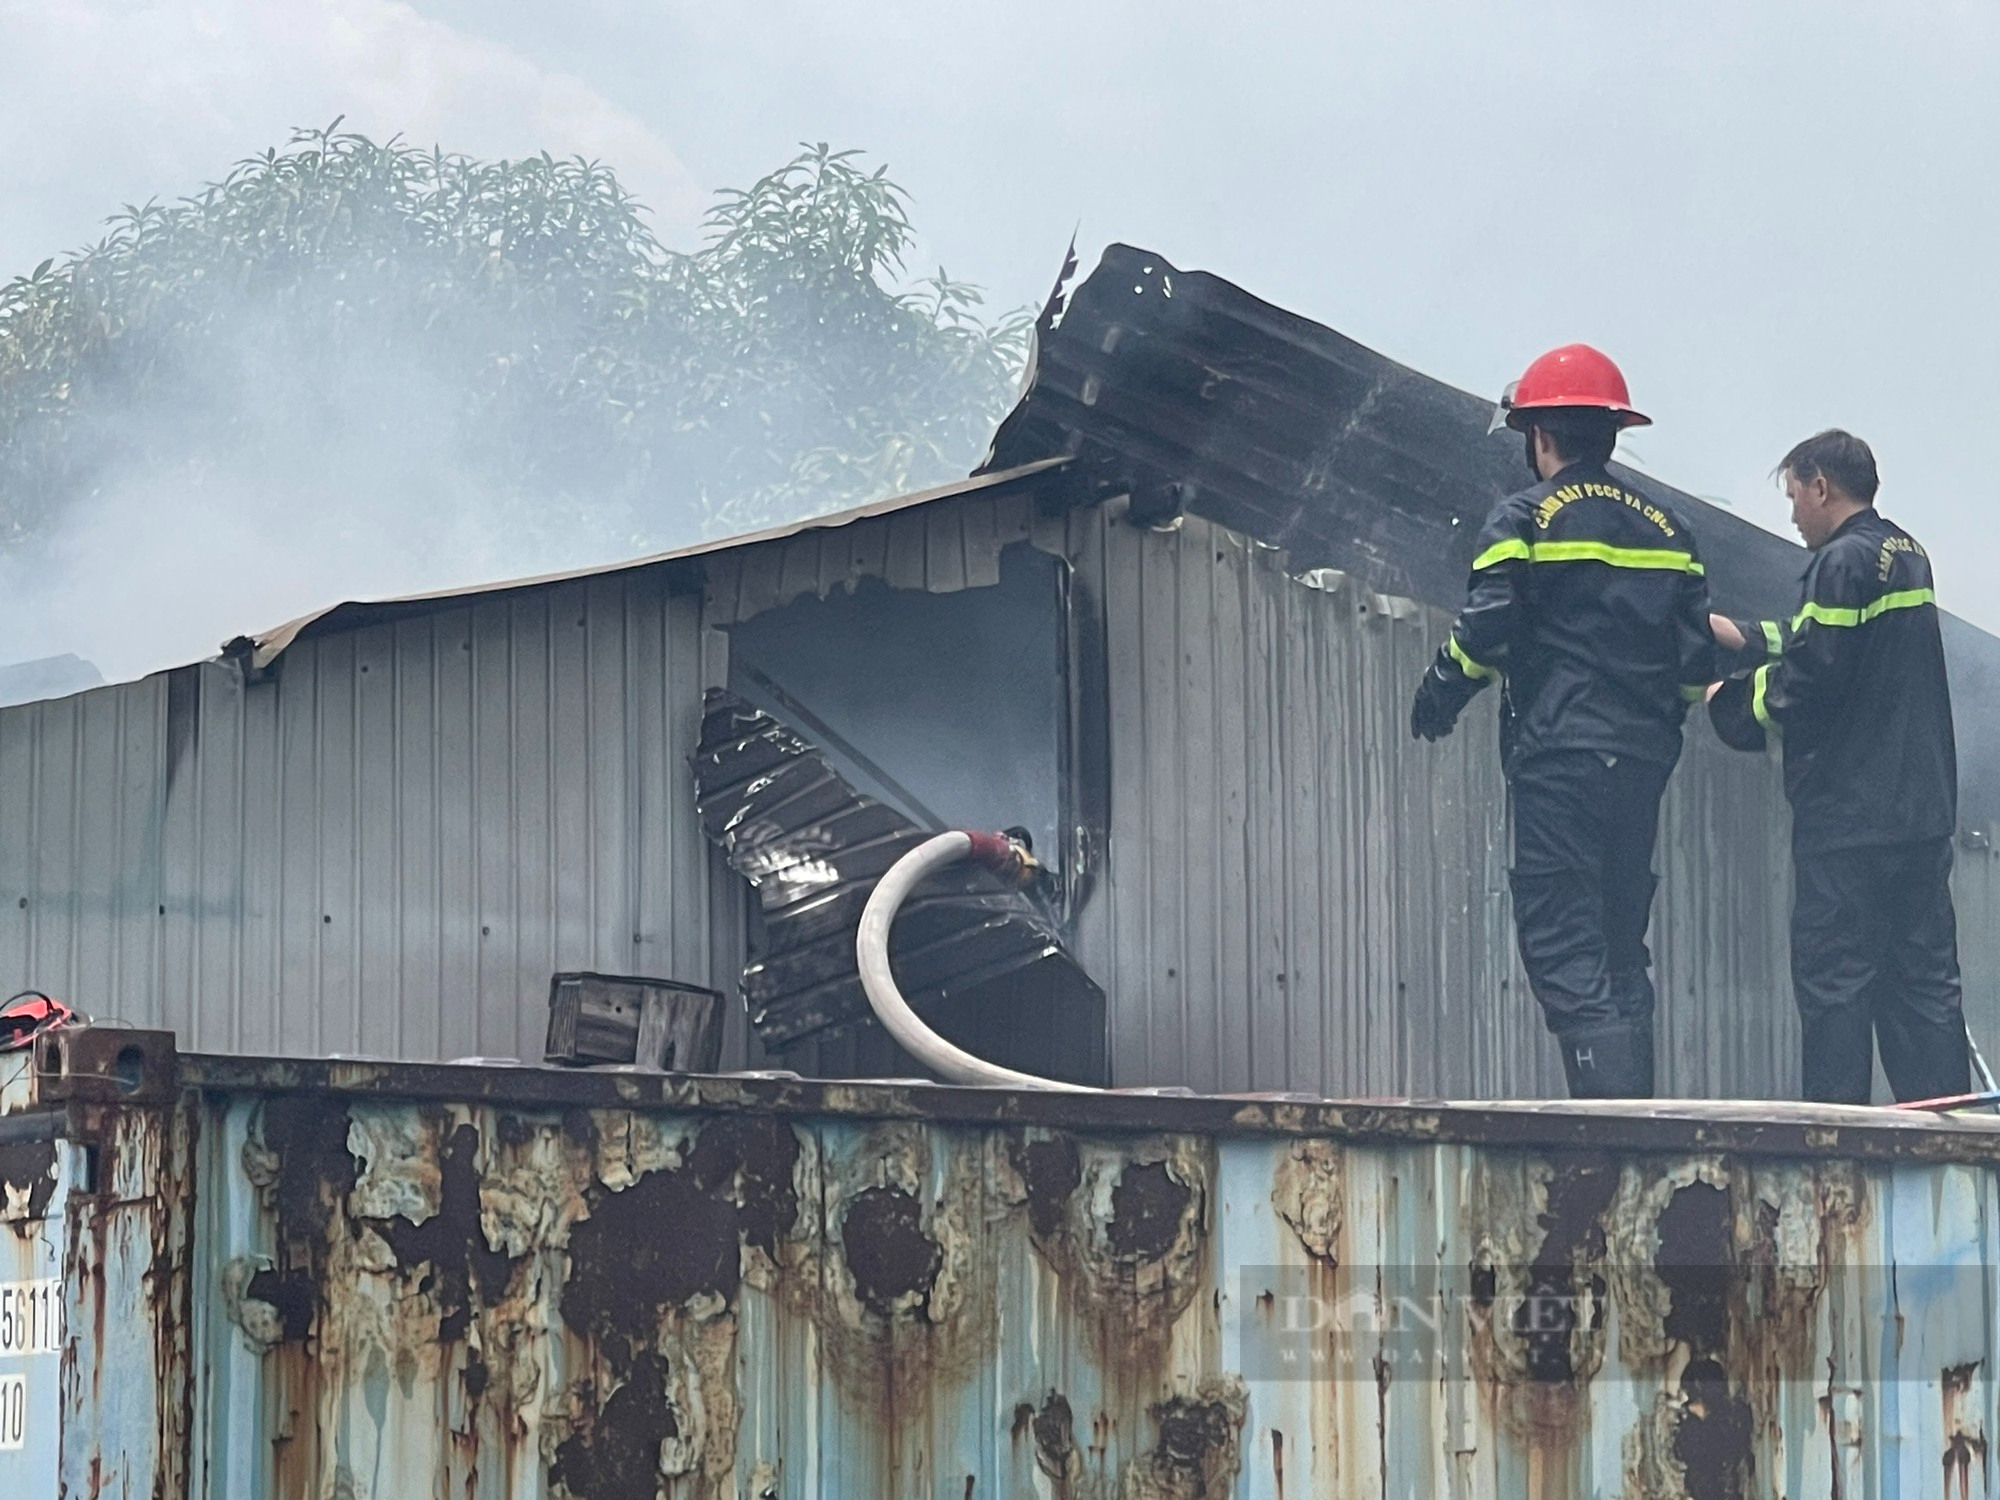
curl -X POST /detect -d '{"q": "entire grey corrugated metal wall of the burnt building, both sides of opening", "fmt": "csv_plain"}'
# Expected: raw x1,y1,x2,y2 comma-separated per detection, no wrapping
0,496,2000,1098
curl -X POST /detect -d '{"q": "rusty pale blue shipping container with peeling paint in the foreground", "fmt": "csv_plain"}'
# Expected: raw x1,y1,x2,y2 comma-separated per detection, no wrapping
0,1028,2000,1500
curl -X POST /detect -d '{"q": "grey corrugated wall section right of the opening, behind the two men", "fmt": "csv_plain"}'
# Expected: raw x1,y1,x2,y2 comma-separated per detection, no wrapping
1076,518,2000,1098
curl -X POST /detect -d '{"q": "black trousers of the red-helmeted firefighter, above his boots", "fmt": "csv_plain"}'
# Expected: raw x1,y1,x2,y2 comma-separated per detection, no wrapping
1508,750,1674,1036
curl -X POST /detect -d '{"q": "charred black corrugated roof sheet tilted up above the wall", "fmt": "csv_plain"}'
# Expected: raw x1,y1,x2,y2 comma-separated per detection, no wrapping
984,244,2000,826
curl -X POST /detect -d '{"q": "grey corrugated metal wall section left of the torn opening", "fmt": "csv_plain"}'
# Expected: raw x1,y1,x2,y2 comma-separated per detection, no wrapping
0,572,740,1060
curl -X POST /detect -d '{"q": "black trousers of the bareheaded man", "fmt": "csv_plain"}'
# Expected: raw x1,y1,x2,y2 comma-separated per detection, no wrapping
1792,838,1972,1104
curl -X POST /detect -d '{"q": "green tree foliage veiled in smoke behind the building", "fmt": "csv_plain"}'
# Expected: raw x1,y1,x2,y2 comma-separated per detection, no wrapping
0,122,1030,544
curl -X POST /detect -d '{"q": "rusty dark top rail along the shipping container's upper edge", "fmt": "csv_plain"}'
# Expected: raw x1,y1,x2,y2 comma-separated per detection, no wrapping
164,1054,2000,1166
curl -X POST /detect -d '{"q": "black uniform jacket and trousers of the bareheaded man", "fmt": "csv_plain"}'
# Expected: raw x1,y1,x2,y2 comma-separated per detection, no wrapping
1710,508,1968,1104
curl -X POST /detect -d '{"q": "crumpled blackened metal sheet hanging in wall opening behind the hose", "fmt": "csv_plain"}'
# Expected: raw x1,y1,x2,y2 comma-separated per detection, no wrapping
694,688,1104,1080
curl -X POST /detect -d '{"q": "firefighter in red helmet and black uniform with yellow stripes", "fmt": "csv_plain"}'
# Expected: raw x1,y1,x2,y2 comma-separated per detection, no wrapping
1410,344,1716,1098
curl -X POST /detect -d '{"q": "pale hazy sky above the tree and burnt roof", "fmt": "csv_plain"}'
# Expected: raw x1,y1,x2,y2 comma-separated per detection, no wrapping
0,0,2000,672
